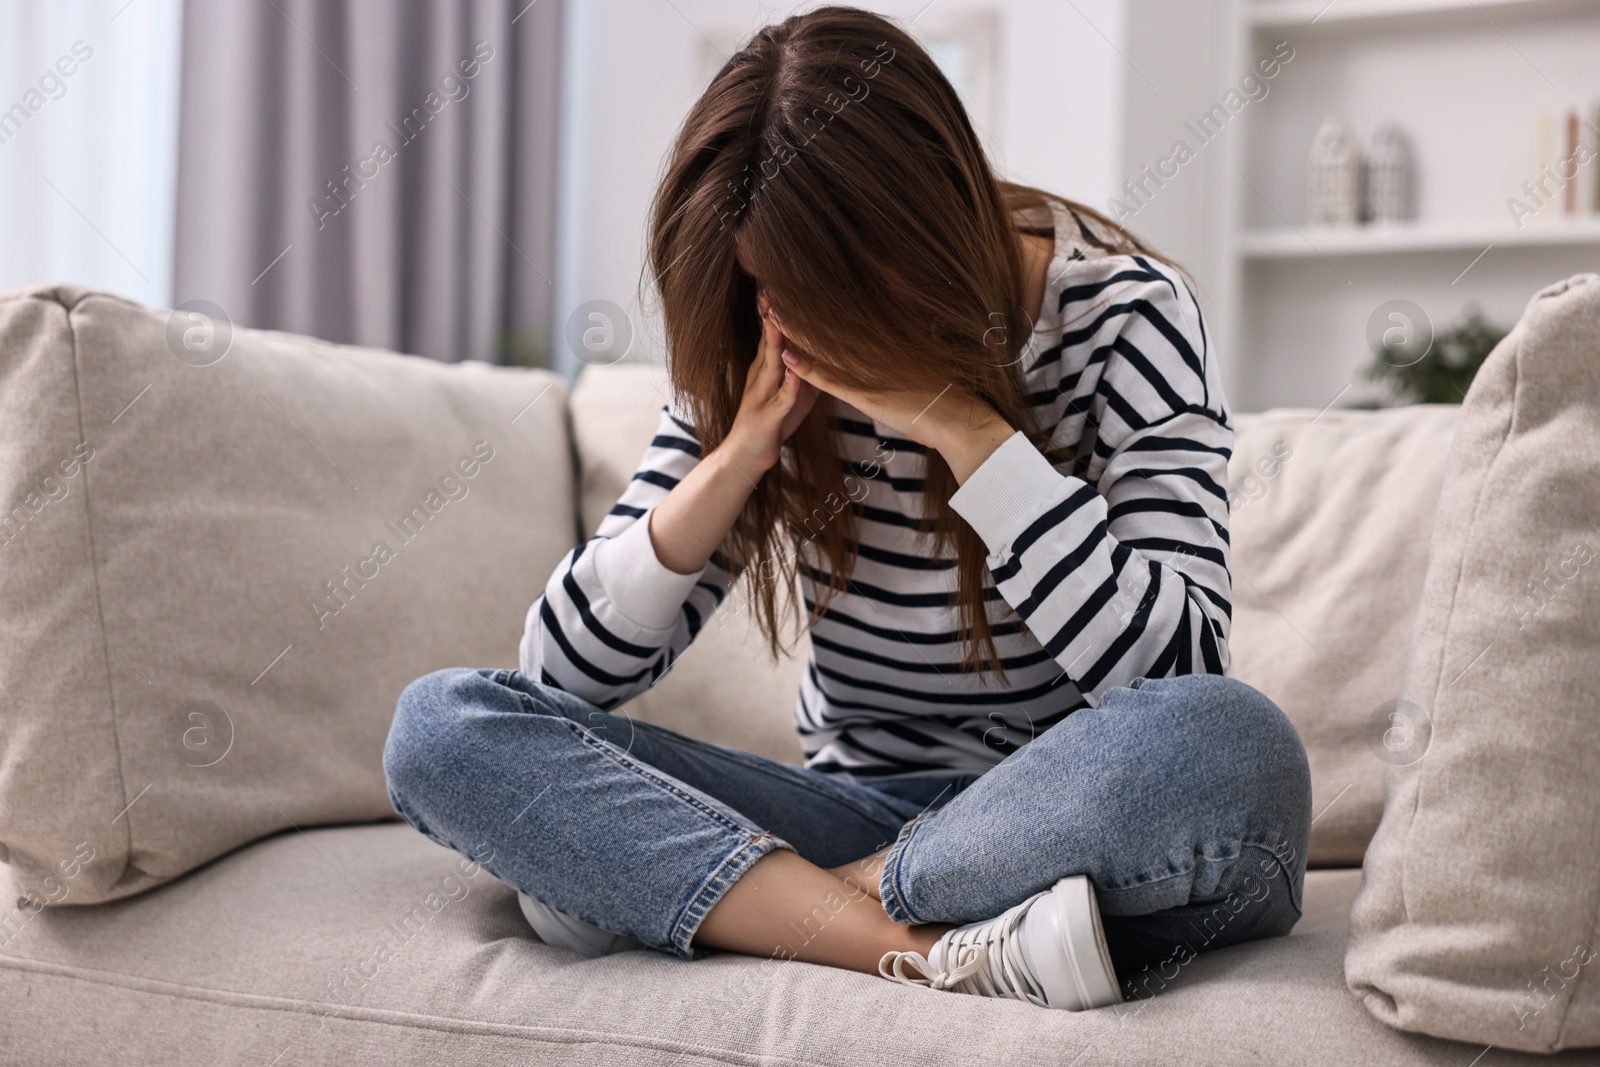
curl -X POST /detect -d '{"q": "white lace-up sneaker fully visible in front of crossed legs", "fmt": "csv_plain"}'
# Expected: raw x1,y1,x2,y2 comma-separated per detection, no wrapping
878,875,1122,1011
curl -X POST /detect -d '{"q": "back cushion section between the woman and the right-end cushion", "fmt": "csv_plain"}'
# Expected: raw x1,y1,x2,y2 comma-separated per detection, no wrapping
1229,405,1459,867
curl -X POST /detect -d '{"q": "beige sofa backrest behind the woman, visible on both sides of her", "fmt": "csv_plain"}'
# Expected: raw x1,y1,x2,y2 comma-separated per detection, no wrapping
573,365,1456,865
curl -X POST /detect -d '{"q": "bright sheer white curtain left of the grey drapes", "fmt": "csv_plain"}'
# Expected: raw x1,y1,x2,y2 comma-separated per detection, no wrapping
0,0,182,307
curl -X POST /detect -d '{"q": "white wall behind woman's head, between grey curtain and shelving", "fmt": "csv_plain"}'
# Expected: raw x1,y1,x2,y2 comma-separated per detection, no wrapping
555,0,1126,371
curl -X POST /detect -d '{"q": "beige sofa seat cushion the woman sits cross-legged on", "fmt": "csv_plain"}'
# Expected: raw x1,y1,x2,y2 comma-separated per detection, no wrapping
0,824,1579,1067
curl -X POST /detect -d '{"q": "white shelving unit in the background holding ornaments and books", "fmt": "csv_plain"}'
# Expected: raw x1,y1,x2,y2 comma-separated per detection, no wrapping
1203,0,1600,410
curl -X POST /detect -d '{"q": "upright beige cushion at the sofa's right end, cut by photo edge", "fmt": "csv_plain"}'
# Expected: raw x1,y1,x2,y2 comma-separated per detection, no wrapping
1347,274,1600,1051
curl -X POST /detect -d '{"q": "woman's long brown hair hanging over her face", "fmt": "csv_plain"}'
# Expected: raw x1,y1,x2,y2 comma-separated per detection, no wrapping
648,6,1154,683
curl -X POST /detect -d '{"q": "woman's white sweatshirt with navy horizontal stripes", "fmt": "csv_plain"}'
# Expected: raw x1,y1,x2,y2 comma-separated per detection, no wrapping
520,202,1234,779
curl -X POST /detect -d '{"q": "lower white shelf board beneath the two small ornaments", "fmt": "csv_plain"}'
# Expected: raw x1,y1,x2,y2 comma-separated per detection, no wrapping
1240,216,1600,259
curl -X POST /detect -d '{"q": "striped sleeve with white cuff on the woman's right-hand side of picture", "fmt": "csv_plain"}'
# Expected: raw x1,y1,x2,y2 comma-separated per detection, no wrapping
950,258,1234,705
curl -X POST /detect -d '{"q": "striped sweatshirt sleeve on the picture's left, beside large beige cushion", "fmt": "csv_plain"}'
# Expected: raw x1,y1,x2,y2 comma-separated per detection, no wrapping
520,405,730,709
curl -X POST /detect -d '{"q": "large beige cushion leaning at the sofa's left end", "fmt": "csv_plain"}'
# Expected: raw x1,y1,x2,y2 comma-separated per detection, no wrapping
0,286,576,904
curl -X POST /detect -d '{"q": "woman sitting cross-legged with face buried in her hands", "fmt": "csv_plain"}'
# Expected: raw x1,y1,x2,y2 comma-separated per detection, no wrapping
384,8,1310,1009
